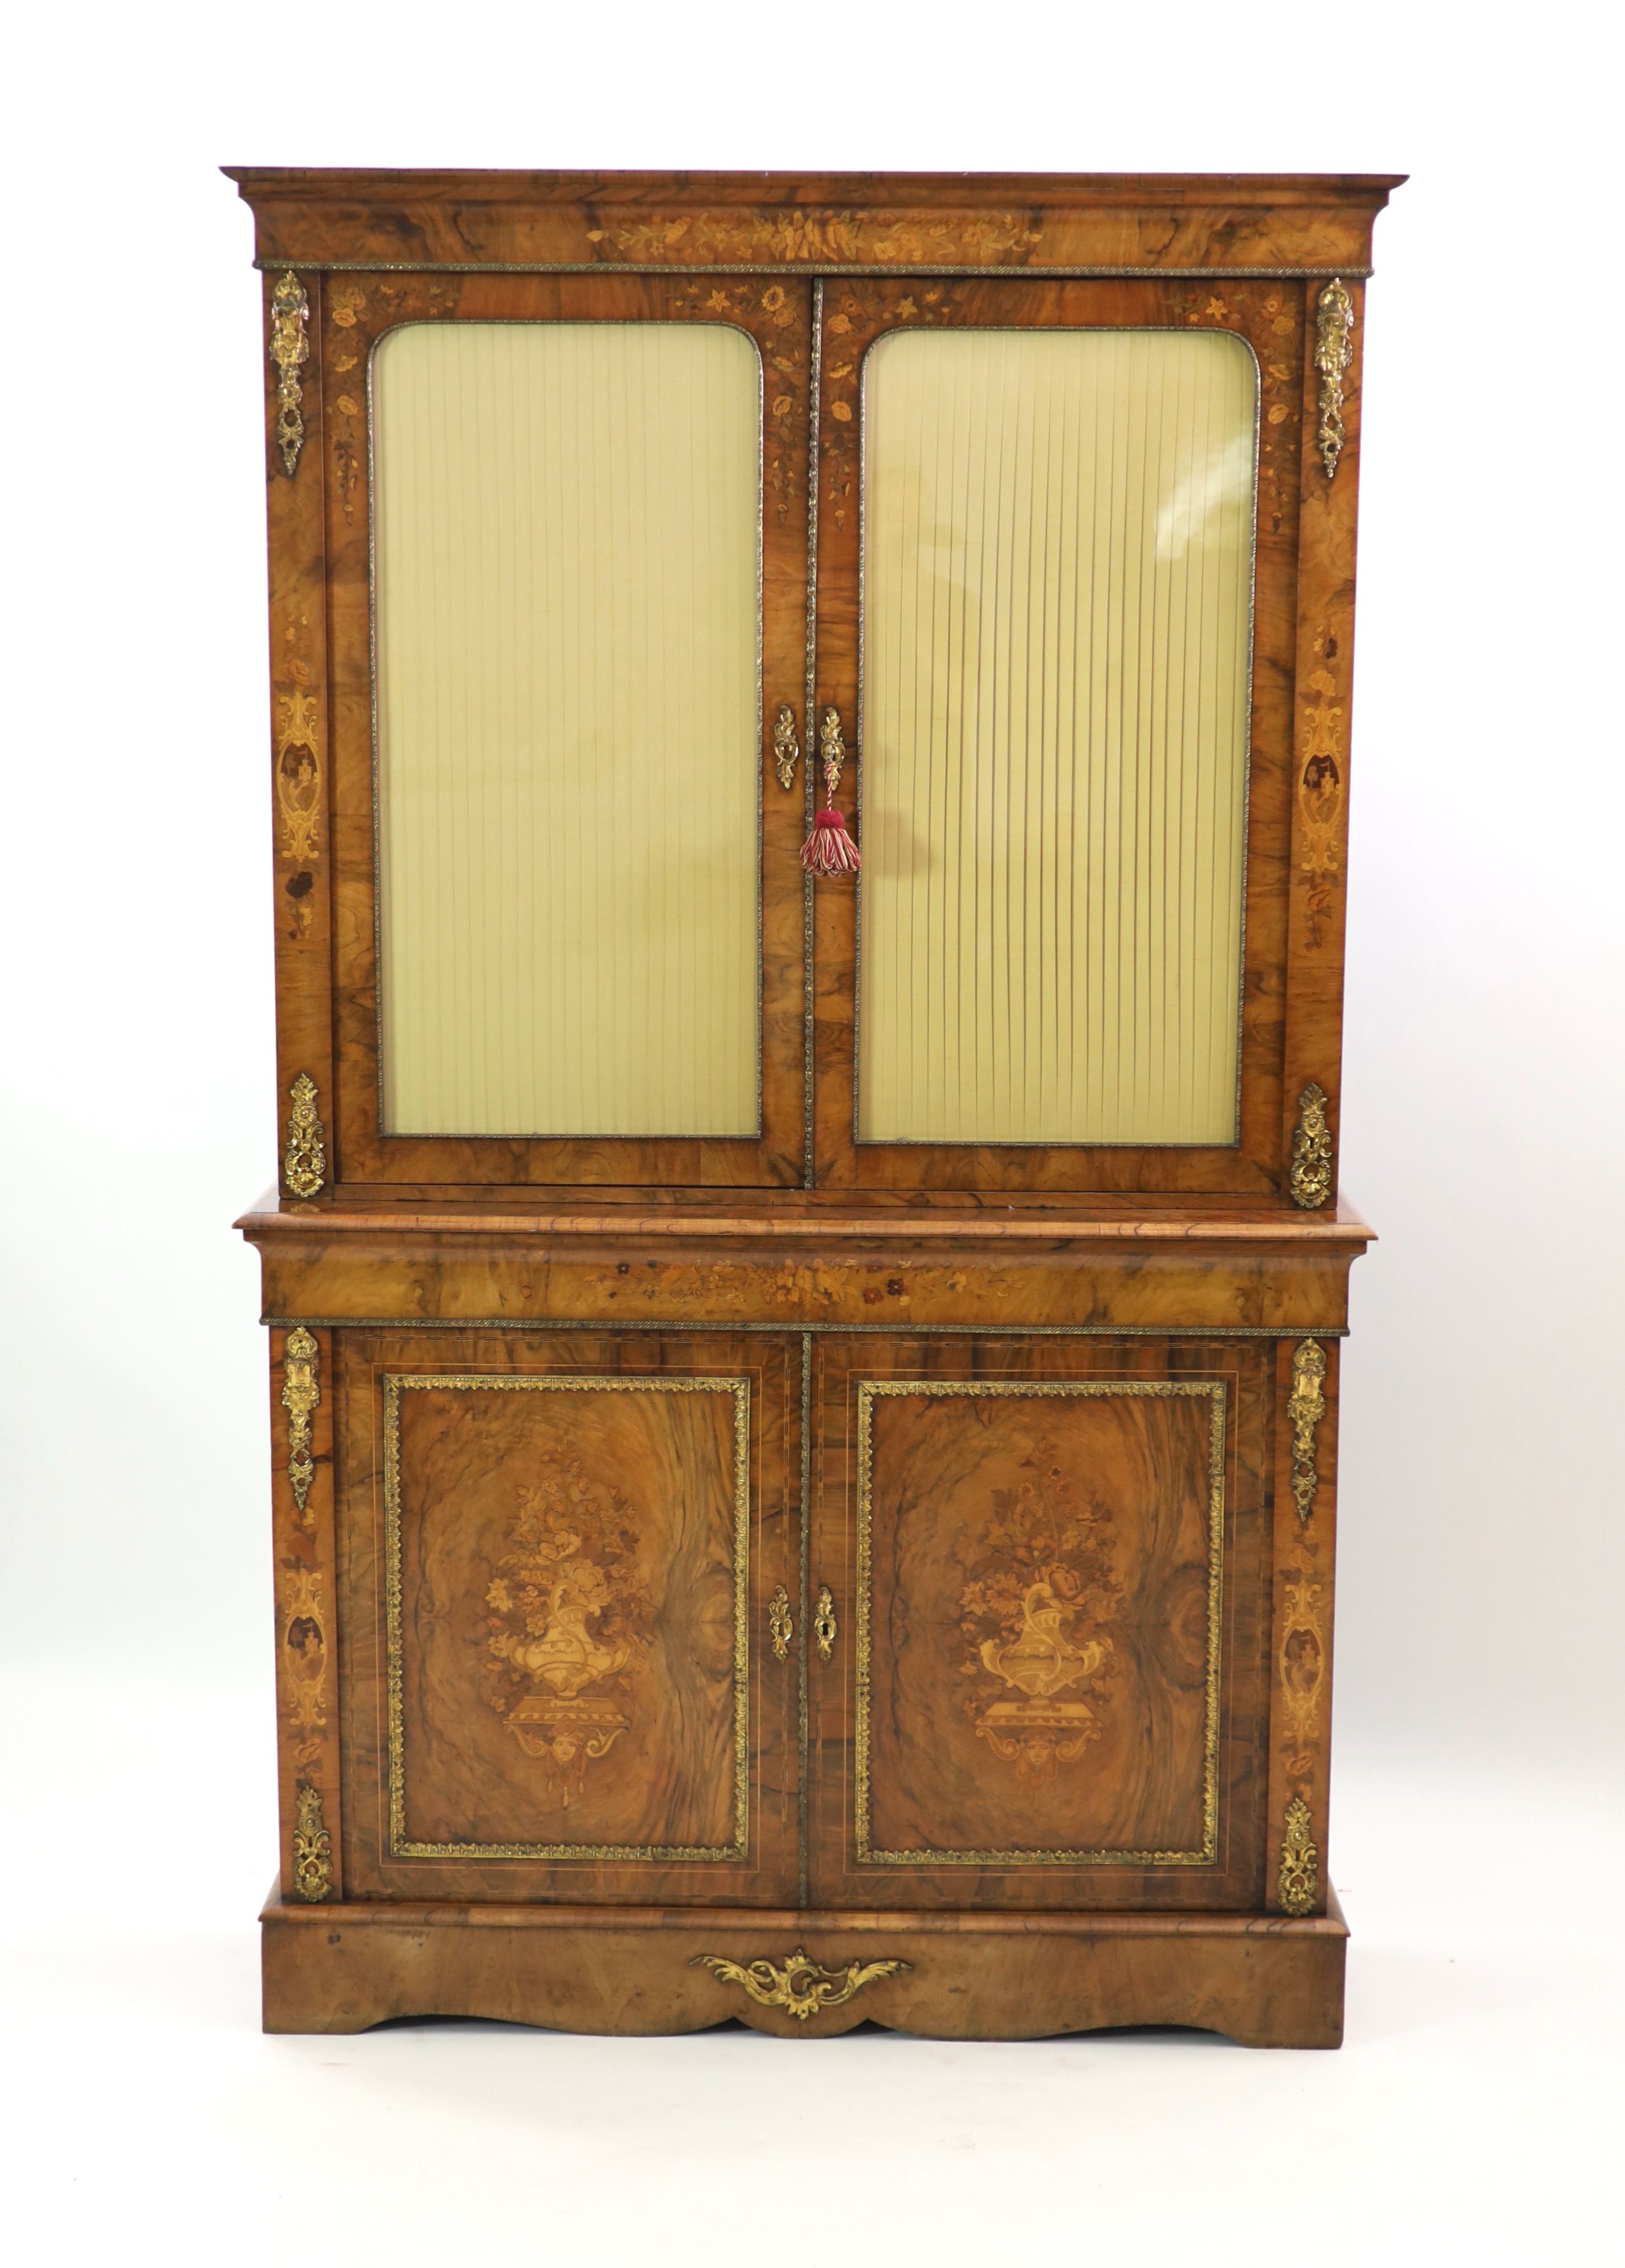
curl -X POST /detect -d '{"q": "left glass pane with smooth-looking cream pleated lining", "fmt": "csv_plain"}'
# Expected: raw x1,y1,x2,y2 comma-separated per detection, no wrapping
372,322,761,1136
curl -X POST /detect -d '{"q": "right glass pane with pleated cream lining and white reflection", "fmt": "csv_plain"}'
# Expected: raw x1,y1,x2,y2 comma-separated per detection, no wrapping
859,331,1258,1143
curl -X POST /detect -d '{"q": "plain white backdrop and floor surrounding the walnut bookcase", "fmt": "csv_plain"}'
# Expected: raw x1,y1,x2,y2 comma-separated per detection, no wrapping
0,0,1625,2261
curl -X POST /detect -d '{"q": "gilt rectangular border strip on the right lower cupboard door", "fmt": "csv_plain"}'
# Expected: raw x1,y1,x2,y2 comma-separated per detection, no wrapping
852,1379,1229,1867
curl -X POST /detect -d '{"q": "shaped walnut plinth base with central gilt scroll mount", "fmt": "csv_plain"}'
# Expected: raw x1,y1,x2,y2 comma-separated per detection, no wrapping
261,1894,1349,2048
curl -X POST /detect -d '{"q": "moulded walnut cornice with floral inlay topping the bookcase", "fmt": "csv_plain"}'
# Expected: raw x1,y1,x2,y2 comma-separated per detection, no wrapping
222,166,1405,275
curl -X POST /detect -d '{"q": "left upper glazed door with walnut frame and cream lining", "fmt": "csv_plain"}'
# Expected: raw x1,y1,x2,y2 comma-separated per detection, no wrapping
319,275,811,1186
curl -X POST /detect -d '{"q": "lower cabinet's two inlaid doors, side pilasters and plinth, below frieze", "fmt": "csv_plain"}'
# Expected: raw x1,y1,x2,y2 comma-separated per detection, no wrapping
265,1327,1347,2046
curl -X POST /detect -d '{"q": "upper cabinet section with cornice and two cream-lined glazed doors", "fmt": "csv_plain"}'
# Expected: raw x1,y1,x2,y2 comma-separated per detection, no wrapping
234,170,1394,1207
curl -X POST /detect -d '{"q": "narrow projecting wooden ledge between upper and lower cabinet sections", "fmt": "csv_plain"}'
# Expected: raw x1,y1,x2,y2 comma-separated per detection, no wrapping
234,1188,1376,1256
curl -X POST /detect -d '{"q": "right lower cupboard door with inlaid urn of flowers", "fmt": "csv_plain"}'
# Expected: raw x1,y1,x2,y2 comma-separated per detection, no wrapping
811,1333,1274,1910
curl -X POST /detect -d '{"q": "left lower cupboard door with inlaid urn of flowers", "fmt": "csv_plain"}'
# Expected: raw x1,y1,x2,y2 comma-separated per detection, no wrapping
336,1331,800,1905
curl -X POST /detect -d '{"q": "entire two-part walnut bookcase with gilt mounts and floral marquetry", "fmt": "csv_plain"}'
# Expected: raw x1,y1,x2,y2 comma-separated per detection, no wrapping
231,168,1396,2046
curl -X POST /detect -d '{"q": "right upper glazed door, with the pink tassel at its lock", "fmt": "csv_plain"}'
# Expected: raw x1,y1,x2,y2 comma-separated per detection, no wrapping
816,277,1328,1198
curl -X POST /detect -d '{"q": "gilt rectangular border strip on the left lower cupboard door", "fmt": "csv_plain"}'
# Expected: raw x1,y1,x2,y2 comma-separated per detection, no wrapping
383,1370,750,1864
